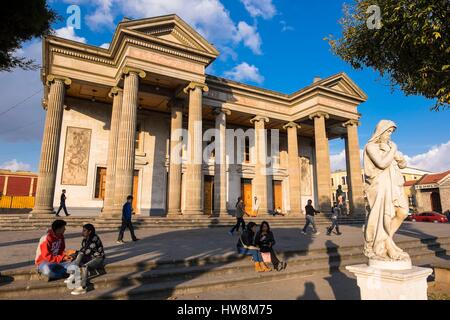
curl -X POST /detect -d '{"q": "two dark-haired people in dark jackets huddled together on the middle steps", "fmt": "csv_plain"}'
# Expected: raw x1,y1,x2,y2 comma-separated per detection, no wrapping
237,221,287,272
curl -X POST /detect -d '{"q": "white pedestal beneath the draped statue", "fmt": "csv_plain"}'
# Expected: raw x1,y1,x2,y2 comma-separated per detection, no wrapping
346,262,433,300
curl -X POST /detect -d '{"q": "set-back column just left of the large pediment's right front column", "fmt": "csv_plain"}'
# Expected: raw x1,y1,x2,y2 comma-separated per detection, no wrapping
167,99,184,216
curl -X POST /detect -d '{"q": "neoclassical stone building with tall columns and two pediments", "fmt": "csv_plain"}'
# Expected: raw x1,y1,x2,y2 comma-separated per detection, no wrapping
32,15,367,218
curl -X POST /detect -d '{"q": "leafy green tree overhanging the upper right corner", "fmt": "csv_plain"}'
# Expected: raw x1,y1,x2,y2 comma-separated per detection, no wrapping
327,0,450,110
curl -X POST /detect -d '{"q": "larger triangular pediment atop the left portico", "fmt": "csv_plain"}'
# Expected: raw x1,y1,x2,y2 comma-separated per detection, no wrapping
118,15,219,56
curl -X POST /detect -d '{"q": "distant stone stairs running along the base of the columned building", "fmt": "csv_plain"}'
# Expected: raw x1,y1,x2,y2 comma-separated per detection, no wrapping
0,214,365,231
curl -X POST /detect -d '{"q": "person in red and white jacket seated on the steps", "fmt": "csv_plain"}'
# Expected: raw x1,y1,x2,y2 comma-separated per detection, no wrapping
35,220,73,280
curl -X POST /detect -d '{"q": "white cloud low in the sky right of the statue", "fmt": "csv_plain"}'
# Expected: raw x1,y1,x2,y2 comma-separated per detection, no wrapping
405,140,450,172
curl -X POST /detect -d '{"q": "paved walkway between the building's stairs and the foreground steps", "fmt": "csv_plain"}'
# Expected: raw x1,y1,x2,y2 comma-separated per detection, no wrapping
0,222,450,272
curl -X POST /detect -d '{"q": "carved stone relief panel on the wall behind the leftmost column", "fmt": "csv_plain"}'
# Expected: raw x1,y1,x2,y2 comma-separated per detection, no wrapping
61,127,91,186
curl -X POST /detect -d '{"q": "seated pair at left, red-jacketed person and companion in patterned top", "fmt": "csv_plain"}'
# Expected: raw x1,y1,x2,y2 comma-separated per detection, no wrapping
35,220,105,295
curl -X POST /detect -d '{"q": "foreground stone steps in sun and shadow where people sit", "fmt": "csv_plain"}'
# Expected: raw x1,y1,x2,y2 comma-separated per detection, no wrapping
0,237,450,299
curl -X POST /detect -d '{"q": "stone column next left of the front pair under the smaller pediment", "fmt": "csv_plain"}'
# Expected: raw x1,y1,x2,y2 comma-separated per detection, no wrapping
283,122,301,215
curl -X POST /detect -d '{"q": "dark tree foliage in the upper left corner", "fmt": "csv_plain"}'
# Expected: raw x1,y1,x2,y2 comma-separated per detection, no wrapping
0,0,58,71
